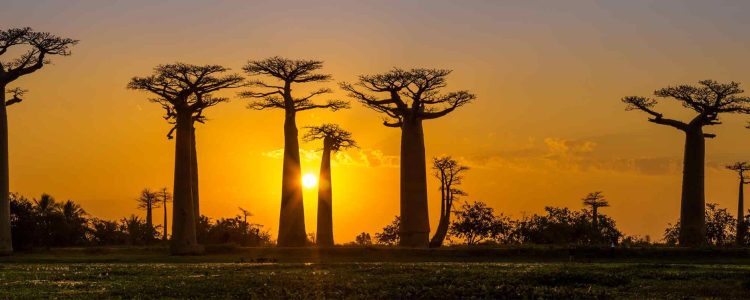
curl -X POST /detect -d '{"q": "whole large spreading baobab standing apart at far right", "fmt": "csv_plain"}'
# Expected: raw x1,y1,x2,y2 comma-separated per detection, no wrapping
622,80,750,246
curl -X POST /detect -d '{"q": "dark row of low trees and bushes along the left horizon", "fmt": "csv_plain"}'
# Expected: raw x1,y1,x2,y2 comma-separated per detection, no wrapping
10,190,273,250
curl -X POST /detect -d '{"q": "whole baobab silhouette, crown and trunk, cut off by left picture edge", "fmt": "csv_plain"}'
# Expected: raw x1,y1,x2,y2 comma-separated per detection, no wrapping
0,27,78,255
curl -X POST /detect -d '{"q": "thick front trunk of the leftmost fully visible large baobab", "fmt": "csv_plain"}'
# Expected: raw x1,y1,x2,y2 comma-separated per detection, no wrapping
170,112,203,255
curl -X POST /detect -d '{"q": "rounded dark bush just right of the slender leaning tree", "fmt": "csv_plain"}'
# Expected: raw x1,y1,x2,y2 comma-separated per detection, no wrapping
450,201,508,245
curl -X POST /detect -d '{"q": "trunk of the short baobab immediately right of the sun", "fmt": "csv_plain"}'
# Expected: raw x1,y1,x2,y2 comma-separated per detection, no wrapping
315,141,333,247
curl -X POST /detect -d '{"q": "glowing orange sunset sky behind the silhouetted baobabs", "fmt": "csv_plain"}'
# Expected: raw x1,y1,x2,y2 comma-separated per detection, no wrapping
0,0,750,242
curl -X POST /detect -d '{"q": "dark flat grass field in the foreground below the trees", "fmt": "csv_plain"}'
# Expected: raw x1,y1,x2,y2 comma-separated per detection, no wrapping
0,248,750,299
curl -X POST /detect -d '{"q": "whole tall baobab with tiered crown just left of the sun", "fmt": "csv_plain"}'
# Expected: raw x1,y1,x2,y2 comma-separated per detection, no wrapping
241,57,349,247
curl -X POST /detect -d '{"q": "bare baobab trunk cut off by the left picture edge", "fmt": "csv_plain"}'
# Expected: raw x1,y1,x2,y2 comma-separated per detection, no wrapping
0,84,13,255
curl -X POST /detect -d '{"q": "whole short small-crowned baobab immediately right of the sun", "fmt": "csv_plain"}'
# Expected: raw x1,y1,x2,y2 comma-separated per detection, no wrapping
303,124,357,247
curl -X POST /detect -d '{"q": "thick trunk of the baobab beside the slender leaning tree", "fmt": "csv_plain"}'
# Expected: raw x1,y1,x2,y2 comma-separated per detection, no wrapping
399,118,430,247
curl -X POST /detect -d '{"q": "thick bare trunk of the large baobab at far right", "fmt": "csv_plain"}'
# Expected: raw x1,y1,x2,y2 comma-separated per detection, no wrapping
679,127,706,247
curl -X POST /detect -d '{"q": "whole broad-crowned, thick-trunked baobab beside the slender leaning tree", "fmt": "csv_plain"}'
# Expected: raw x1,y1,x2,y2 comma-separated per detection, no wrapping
341,68,475,247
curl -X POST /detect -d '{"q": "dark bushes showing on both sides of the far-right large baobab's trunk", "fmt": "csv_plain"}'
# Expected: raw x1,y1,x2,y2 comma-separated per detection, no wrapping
664,203,737,246
